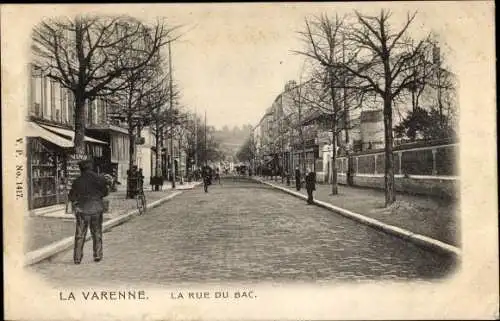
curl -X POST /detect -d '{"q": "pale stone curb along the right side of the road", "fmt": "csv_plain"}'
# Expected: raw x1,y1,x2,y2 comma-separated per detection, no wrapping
253,178,462,257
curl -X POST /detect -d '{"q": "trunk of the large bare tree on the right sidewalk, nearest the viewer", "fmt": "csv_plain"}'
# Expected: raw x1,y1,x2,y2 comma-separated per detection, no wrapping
384,93,396,207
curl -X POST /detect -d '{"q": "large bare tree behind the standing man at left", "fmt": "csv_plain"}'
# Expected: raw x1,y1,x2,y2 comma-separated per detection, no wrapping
32,16,175,154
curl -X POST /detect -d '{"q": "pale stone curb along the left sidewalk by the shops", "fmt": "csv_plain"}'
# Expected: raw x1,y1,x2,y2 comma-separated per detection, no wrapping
23,185,186,266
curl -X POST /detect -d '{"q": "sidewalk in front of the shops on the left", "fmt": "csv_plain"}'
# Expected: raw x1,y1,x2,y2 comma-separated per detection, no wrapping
24,183,199,253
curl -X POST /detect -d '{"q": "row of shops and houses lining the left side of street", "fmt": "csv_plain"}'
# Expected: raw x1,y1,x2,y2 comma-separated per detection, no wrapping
25,65,187,209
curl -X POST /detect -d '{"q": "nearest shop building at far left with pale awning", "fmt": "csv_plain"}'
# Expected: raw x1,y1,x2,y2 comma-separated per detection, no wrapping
25,65,113,210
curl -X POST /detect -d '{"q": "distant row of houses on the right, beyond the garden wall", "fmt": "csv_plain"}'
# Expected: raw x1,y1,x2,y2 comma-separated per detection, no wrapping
252,81,384,181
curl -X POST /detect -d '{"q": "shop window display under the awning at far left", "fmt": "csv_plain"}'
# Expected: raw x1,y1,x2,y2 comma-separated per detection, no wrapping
28,138,67,209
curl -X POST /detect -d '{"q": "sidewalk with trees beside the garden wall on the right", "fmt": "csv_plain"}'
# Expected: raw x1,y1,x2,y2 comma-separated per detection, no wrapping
258,177,460,246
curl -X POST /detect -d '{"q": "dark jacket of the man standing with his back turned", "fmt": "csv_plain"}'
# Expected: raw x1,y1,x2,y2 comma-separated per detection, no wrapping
68,170,108,215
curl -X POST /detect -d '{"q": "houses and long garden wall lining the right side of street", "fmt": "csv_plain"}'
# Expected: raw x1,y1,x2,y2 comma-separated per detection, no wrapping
251,81,458,195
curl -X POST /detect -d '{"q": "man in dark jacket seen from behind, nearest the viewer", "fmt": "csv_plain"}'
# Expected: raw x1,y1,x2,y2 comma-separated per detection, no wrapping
68,160,108,264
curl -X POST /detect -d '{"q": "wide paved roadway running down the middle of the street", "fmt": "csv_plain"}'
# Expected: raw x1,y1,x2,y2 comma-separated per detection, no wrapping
30,180,455,286
